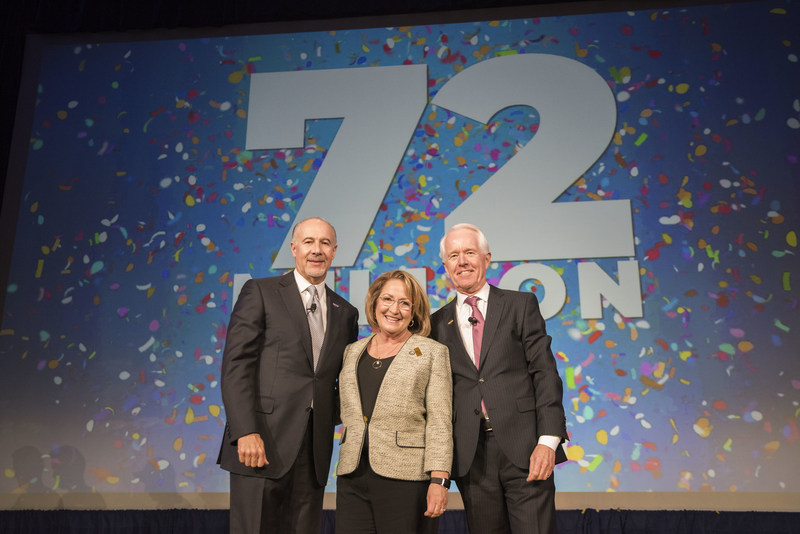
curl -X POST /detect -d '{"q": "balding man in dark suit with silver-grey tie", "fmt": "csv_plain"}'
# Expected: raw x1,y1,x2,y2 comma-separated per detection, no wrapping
217,218,358,534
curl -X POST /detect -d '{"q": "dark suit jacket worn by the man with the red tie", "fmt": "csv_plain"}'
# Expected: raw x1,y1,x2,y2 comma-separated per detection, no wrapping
431,286,567,476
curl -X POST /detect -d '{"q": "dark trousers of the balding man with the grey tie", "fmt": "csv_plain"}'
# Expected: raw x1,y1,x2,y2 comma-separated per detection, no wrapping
230,422,325,534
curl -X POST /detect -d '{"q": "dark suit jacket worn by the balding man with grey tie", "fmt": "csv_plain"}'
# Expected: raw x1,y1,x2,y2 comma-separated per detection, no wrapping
217,272,358,485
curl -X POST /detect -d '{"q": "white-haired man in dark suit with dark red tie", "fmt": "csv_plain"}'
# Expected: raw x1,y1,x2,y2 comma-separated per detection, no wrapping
431,224,567,534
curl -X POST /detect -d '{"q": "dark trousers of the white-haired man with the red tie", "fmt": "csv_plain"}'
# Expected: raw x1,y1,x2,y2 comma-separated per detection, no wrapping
456,429,556,534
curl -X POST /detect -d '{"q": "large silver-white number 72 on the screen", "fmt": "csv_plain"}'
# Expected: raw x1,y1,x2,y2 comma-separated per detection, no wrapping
246,54,634,269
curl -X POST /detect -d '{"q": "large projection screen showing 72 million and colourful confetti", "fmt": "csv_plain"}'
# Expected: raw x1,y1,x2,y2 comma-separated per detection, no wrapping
0,2,800,510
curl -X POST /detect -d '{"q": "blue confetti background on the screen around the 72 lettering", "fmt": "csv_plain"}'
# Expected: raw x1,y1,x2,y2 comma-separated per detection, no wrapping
0,1,800,500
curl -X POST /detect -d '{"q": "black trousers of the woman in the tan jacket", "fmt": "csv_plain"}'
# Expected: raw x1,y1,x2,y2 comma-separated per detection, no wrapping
336,447,439,534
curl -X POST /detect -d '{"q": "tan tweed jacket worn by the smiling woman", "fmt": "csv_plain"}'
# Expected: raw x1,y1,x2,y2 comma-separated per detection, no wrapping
336,334,453,480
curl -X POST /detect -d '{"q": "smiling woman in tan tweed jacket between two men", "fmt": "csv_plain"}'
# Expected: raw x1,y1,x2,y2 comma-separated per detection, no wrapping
336,271,453,534
